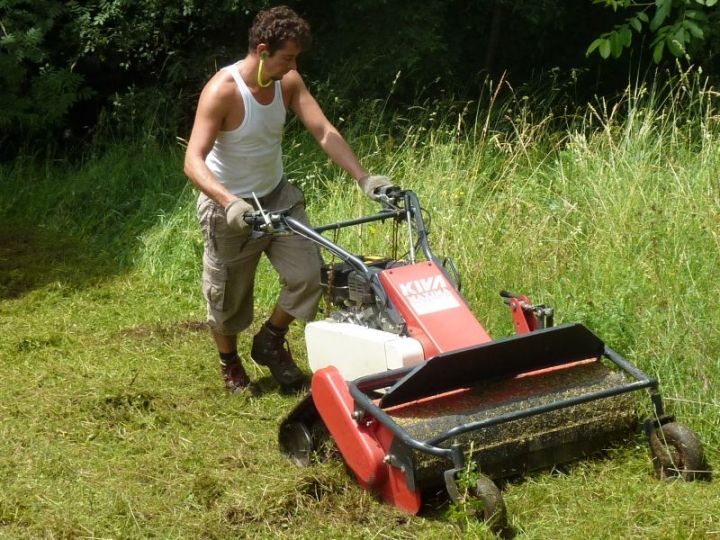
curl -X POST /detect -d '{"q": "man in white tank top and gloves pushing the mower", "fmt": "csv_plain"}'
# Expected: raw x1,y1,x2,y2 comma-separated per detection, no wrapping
185,6,390,392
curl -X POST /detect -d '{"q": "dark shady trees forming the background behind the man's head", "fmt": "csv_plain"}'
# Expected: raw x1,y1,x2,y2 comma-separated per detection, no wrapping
0,0,720,158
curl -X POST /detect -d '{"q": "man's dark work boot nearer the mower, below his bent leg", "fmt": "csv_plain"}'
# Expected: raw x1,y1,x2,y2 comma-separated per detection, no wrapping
250,323,307,390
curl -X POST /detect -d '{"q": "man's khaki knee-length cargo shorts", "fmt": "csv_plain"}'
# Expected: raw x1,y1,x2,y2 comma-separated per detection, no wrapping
197,179,322,336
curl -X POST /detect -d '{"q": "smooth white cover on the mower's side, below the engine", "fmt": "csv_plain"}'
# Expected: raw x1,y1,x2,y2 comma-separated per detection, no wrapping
305,320,424,381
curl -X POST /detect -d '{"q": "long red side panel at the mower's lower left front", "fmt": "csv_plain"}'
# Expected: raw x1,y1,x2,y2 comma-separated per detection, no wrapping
312,366,387,489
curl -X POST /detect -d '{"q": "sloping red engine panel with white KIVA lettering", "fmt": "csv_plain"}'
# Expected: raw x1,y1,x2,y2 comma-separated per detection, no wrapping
380,261,490,359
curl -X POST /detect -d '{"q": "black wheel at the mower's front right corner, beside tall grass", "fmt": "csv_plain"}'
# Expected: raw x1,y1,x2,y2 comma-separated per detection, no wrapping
650,422,707,480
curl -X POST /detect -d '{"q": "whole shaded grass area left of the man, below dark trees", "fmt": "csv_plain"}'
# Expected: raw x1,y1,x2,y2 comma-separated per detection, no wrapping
0,140,194,299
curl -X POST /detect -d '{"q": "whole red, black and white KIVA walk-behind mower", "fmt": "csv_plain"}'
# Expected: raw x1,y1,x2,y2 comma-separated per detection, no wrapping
248,188,709,529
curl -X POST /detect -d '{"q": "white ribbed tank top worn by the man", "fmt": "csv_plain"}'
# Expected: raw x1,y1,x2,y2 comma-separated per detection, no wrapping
205,64,285,198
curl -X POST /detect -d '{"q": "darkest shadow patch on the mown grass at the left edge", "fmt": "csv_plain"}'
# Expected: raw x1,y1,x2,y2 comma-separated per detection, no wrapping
0,223,123,300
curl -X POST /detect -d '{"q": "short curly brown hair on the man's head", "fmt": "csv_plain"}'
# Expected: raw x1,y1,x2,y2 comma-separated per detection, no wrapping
248,6,312,55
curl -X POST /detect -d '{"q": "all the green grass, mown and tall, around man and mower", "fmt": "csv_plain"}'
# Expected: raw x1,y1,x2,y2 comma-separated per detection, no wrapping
0,70,720,539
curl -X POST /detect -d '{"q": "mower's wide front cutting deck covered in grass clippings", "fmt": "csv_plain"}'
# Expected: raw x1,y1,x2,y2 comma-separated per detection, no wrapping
385,360,637,485
